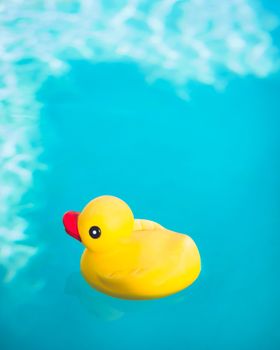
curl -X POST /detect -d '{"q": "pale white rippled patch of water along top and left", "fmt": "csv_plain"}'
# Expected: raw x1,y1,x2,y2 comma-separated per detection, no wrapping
0,0,279,281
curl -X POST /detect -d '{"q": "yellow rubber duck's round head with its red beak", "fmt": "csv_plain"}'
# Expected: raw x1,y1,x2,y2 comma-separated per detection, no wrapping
63,196,134,252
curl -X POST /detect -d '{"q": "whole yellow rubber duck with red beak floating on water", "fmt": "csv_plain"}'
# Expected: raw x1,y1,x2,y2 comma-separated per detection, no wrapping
63,196,200,299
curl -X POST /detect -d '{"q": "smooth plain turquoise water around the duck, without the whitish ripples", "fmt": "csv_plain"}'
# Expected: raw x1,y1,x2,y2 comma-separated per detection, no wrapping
0,0,280,350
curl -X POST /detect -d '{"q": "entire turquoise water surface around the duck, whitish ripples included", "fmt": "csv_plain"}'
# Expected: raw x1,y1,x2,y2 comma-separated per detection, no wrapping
0,1,280,350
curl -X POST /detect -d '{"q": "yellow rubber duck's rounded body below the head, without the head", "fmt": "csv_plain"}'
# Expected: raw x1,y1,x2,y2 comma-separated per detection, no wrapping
63,196,200,299
